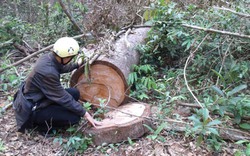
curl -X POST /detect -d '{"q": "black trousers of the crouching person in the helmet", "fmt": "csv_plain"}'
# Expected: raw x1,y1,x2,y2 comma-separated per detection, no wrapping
26,88,81,132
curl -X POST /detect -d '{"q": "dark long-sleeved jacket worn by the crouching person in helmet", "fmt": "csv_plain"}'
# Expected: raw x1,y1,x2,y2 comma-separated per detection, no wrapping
13,53,86,128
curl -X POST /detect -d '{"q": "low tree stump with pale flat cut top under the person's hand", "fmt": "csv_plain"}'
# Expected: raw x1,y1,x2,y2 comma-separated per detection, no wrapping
84,103,151,145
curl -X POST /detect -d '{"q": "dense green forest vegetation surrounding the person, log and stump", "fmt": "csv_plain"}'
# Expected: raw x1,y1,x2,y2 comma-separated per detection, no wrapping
0,0,250,156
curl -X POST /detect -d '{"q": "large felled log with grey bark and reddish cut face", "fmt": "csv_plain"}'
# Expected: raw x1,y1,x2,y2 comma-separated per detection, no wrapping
70,28,149,107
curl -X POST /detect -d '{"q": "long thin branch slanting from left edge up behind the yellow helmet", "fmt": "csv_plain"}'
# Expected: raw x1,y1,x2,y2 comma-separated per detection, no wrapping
0,34,89,73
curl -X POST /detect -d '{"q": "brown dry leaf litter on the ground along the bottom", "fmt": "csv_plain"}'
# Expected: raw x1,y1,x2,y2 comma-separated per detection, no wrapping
0,99,245,156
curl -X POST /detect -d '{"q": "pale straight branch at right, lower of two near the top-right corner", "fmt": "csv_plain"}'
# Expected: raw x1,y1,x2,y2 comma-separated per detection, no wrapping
182,24,250,39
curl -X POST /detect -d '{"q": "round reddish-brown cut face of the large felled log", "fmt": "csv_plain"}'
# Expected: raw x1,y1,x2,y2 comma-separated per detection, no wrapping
70,61,127,107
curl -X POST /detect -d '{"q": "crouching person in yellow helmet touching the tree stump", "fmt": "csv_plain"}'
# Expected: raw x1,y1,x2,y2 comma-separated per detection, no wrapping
13,37,101,132
